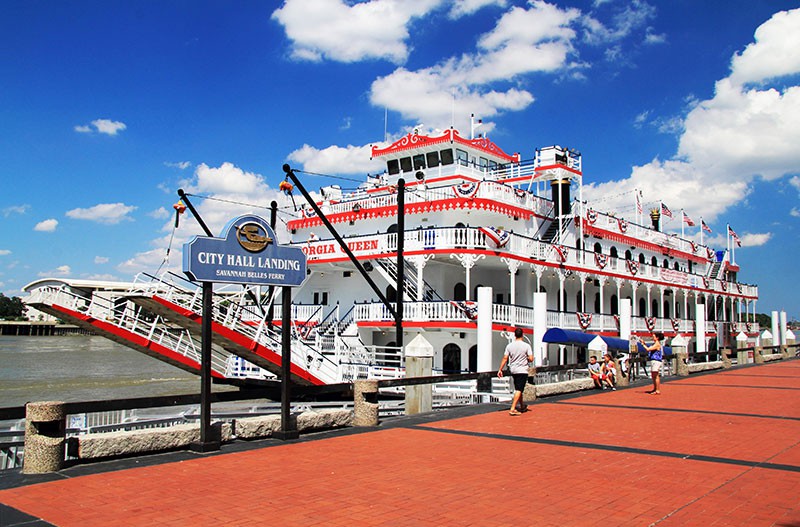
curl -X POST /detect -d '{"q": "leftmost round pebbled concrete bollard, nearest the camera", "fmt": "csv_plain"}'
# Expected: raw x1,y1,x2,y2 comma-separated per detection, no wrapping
22,401,67,474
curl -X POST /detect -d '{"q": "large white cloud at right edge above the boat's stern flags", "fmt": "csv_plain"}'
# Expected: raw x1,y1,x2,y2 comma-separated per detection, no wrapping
584,10,800,224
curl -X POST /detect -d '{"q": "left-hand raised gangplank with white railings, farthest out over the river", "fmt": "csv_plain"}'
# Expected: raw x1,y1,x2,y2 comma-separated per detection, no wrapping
26,286,235,384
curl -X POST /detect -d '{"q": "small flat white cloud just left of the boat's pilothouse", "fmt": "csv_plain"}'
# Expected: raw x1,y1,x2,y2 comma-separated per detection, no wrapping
289,145,384,174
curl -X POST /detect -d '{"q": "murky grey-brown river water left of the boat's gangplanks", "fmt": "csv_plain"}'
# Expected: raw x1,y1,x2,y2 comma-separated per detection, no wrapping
0,335,216,407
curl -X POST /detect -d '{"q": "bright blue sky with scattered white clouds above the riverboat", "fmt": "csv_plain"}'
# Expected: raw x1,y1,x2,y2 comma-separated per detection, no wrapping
0,0,800,320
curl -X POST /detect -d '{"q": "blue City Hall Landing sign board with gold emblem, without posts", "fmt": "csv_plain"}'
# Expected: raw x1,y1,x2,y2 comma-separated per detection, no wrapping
183,215,306,286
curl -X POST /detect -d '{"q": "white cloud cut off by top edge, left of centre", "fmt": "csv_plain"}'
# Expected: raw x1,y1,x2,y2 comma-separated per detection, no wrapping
272,0,443,64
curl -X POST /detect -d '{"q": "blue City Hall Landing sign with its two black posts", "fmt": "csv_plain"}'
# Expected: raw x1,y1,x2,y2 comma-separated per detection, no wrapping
183,215,306,446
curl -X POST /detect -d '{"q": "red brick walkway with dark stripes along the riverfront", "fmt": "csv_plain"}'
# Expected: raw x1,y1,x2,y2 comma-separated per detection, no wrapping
0,360,800,527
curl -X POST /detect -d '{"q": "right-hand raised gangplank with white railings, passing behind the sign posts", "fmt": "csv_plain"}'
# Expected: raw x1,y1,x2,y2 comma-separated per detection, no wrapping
127,275,341,385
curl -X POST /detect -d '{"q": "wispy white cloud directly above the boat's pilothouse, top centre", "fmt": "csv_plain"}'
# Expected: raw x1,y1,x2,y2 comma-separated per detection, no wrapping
370,0,582,131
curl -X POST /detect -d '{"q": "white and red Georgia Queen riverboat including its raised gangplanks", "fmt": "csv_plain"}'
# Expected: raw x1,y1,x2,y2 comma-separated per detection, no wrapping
21,128,759,384
